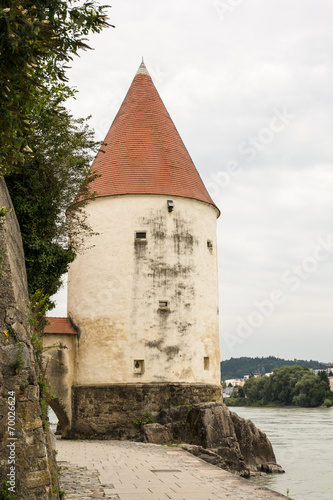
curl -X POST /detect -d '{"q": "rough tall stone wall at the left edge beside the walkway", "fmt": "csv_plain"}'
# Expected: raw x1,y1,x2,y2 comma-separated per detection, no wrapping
0,178,59,500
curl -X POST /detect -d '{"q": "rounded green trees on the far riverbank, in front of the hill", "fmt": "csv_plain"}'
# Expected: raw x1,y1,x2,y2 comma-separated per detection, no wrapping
225,365,333,407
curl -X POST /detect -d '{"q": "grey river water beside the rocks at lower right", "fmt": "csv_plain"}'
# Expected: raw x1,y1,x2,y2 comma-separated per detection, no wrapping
230,407,333,500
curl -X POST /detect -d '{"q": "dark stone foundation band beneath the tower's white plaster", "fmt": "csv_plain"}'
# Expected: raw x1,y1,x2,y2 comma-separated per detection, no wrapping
70,384,222,439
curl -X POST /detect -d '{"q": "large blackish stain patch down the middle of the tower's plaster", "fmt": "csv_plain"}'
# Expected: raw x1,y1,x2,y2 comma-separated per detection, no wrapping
132,206,198,336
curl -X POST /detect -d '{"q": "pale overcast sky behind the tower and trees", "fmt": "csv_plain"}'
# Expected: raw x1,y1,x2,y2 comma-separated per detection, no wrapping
51,0,333,361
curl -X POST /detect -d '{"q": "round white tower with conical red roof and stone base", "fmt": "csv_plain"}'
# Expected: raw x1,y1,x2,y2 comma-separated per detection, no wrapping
68,63,221,434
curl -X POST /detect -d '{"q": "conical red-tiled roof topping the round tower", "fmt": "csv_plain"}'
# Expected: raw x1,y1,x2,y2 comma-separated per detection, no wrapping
87,62,219,213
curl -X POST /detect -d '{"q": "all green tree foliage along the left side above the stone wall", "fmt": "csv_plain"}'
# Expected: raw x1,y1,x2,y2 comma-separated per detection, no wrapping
0,0,110,296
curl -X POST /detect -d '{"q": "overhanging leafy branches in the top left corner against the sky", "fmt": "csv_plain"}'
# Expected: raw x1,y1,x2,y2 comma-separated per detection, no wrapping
0,0,109,173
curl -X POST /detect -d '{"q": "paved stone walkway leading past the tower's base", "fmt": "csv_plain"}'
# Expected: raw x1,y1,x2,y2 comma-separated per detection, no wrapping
57,440,286,500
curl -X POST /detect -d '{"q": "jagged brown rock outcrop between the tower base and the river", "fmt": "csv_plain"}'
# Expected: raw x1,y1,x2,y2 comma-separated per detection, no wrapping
151,403,283,477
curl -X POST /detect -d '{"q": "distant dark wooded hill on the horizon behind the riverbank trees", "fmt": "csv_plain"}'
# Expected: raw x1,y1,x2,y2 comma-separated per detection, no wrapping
221,356,326,380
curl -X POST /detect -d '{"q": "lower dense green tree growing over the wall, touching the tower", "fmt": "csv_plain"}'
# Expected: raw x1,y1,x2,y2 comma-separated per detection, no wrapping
6,99,99,304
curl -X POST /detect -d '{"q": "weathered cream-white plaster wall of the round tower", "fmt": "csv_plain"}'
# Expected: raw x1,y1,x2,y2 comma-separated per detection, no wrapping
68,195,220,385
